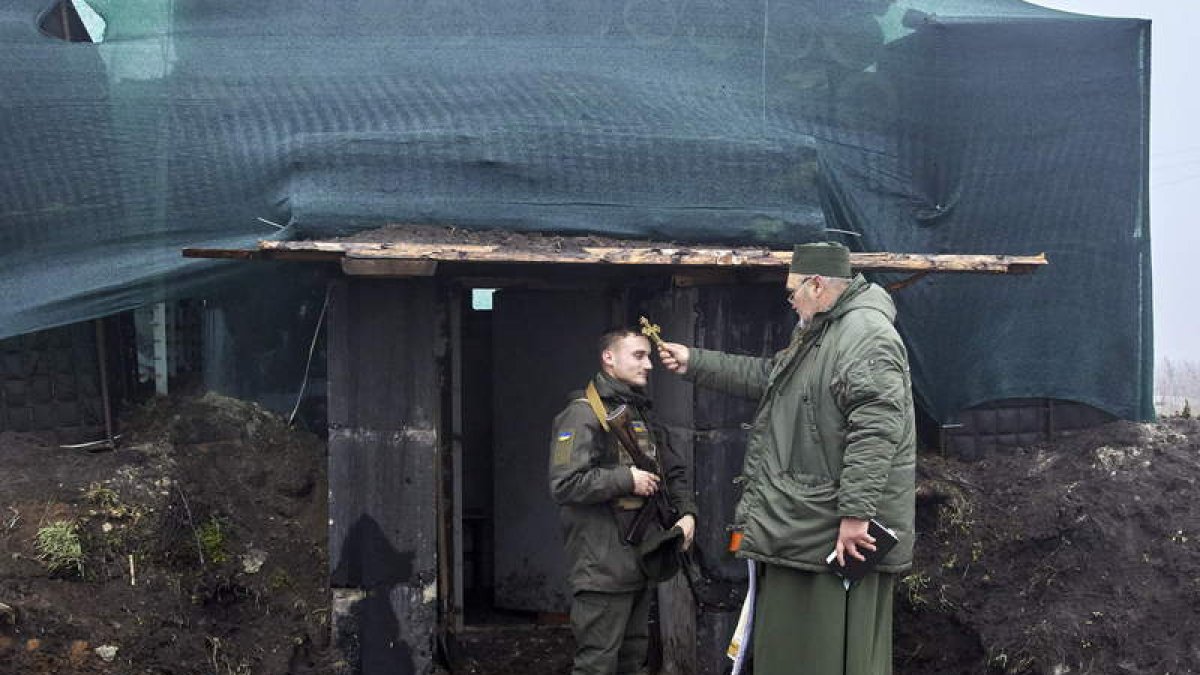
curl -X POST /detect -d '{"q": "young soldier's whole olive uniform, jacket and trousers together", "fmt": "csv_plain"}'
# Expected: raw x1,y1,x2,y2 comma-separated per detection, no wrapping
550,372,696,675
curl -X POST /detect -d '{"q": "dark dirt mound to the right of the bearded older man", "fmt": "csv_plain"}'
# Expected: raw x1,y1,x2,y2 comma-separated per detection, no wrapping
896,419,1200,675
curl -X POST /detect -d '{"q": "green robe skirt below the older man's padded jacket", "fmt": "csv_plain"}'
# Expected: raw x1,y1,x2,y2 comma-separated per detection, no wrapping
750,565,895,675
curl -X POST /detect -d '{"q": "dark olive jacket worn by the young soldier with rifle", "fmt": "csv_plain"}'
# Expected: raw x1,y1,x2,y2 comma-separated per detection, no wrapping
550,372,696,592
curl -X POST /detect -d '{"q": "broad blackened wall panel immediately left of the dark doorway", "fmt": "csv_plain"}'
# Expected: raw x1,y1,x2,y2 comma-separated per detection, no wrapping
329,279,444,675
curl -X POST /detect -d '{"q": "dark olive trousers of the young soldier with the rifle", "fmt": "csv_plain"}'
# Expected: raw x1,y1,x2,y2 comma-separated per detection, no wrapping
571,589,650,675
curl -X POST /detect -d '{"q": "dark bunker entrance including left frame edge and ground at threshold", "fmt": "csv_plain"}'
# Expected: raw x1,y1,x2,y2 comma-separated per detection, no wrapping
443,287,622,674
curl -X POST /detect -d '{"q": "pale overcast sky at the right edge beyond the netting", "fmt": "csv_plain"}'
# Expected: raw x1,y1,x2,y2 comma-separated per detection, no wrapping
1034,0,1200,362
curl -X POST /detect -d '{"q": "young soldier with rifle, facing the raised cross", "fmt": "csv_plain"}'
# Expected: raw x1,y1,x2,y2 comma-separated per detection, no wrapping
550,330,696,675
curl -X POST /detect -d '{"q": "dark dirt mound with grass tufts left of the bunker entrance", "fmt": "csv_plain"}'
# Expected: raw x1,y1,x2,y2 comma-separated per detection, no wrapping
0,394,334,675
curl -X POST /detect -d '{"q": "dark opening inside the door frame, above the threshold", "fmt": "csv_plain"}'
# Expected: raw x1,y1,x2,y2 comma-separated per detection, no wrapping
454,288,616,625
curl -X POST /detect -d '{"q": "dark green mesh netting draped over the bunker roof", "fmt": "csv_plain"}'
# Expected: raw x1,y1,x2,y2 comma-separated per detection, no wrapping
0,0,1152,422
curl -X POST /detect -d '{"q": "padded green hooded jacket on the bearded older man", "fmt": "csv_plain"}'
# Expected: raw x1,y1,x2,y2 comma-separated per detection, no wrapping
685,275,917,572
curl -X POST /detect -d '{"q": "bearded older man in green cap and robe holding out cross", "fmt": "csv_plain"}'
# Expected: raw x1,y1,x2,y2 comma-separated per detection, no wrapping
659,244,917,675
